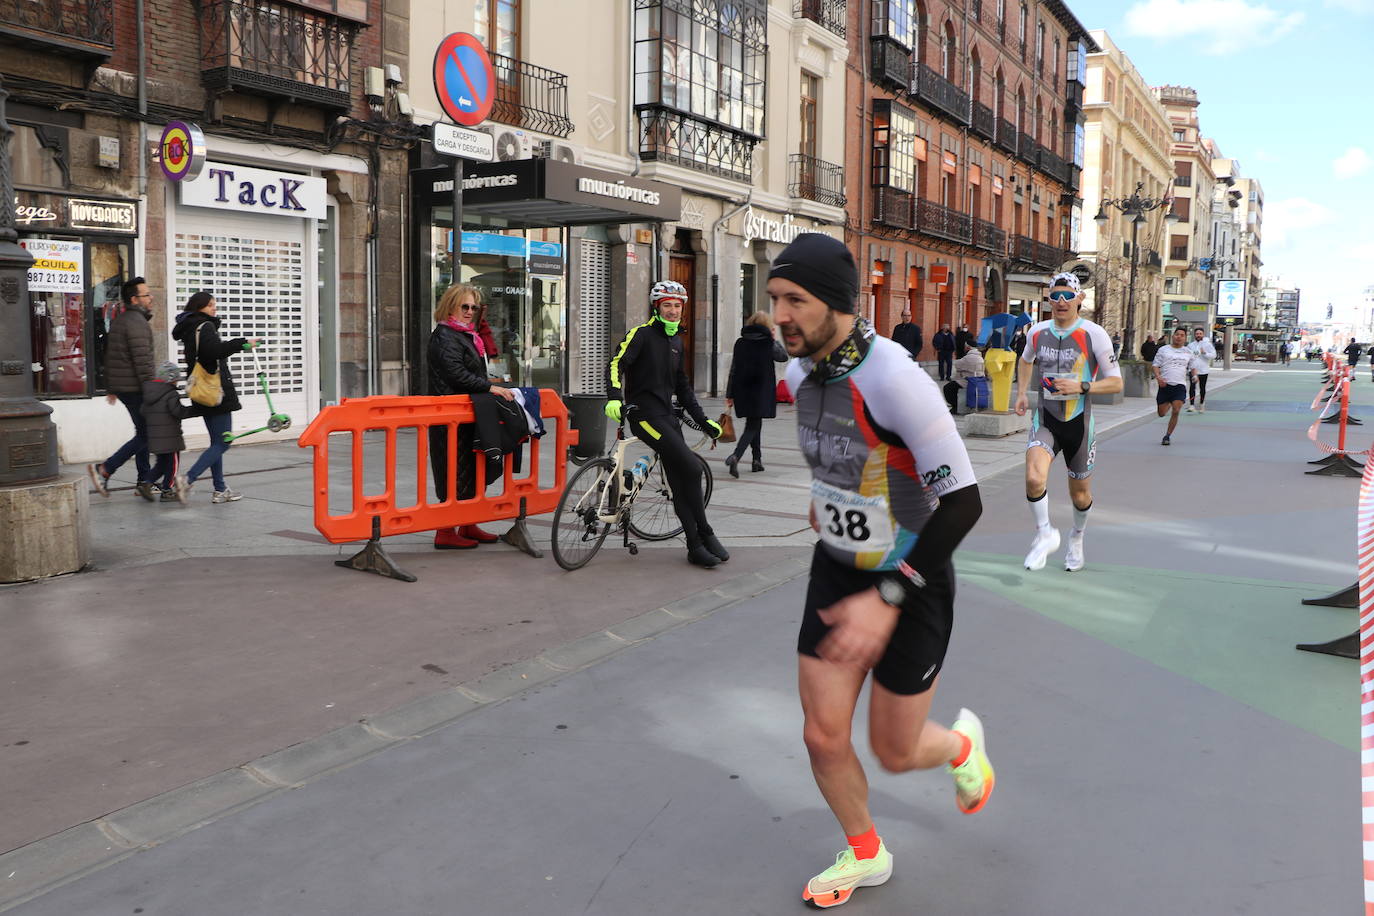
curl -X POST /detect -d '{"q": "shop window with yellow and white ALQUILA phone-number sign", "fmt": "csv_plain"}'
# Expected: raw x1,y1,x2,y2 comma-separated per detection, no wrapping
19,235,132,397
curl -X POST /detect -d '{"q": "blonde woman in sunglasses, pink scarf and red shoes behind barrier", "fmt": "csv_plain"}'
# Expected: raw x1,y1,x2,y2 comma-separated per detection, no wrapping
429,283,515,551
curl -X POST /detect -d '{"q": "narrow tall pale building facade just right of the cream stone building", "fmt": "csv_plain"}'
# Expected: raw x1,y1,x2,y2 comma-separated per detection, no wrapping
1154,87,1216,336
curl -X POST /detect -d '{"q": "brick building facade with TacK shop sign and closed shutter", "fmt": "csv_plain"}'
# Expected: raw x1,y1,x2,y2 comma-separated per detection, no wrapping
0,0,400,461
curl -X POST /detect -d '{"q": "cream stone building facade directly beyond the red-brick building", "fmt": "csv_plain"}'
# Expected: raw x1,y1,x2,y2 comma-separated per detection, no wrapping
1079,32,1173,354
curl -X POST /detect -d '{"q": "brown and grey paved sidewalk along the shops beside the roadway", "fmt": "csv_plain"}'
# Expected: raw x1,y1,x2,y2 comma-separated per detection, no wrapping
10,365,1344,912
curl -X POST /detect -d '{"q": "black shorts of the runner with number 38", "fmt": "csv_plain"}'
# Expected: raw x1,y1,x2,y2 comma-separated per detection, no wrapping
797,544,954,696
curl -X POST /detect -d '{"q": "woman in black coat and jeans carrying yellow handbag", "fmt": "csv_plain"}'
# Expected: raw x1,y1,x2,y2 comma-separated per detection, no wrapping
172,290,261,503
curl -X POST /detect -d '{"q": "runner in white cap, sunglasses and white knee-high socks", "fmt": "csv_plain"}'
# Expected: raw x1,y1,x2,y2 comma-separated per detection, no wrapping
1017,273,1121,573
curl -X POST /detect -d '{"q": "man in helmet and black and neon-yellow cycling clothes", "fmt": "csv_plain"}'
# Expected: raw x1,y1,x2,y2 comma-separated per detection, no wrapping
606,280,730,569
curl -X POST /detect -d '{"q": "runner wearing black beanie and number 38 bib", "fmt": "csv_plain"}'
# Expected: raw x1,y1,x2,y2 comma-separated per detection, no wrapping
768,232,993,906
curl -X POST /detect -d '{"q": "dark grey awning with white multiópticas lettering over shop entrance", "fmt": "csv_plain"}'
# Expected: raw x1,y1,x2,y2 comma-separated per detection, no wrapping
411,159,683,228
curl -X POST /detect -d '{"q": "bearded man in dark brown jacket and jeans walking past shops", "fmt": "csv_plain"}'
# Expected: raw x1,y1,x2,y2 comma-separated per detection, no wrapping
87,276,155,500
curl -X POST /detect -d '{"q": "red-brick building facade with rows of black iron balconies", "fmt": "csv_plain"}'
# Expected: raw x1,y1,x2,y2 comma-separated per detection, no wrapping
846,0,1096,347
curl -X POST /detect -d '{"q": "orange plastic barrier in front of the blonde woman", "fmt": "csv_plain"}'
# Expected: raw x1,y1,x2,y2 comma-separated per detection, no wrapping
297,389,578,544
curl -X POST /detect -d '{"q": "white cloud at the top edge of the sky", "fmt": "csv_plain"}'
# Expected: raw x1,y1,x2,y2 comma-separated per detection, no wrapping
1125,0,1302,55
